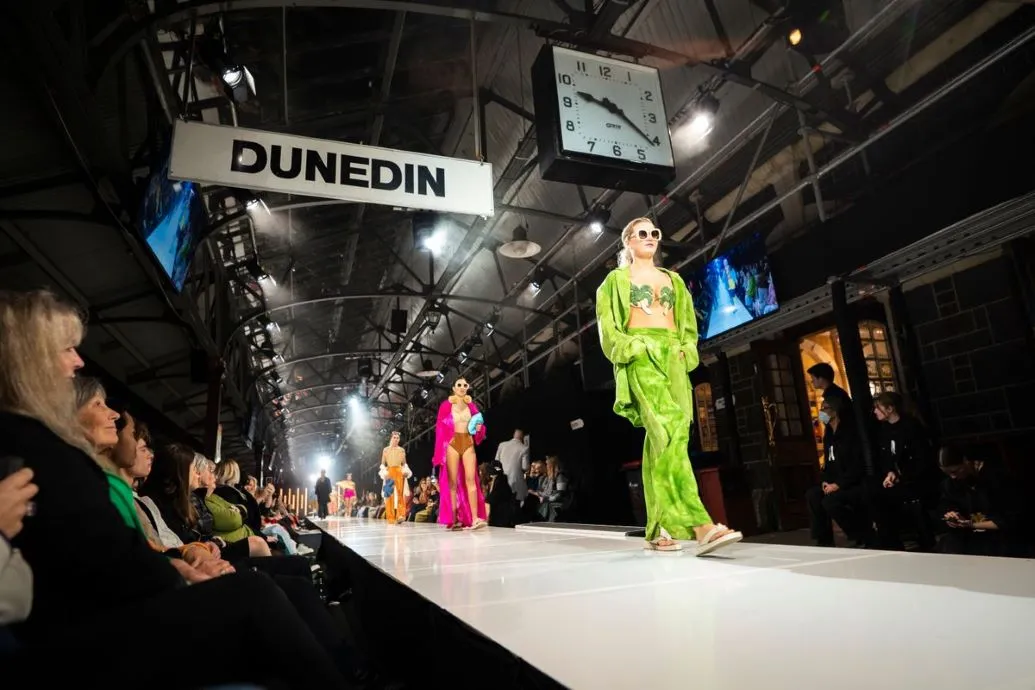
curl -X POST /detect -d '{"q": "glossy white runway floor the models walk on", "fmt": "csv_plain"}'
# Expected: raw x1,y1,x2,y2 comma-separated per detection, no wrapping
321,518,1035,690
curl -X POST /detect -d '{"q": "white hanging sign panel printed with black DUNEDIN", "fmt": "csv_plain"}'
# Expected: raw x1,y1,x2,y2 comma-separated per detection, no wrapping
169,121,494,216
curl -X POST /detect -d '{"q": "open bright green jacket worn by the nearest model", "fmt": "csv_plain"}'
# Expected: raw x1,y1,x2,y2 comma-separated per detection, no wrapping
596,267,701,426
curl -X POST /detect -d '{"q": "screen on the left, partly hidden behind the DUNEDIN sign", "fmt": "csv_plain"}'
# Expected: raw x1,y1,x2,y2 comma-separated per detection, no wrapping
140,155,204,292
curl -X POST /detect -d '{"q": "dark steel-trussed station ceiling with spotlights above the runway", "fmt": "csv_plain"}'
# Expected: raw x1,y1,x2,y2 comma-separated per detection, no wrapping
0,0,1035,477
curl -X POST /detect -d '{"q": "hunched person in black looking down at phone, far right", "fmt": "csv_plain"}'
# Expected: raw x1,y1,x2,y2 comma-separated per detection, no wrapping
938,447,1030,556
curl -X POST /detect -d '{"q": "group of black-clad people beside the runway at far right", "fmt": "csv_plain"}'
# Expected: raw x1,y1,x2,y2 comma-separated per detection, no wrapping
805,365,1031,556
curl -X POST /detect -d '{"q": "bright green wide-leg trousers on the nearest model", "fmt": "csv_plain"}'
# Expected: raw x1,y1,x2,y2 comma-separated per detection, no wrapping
626,328,711,541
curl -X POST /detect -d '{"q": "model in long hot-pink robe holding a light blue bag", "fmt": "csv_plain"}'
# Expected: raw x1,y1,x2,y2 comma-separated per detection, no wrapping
432,379,485,530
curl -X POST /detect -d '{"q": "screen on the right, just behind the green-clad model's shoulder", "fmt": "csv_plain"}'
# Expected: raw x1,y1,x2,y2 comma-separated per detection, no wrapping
687,235,779,340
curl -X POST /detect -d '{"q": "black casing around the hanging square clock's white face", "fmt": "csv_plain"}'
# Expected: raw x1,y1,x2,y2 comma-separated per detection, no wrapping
532,43,676,194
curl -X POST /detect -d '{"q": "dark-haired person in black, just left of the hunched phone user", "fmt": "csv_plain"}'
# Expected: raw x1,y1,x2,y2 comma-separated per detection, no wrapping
874,392,939,551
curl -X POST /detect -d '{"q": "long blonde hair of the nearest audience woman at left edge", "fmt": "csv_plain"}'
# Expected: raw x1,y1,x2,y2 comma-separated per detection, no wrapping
0,290,97,461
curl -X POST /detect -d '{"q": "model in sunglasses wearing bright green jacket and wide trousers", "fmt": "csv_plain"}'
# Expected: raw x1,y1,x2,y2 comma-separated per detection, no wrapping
596,218,743,556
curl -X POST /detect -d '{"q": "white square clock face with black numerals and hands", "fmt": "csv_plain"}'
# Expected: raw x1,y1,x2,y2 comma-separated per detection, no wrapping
554,47,673,168
